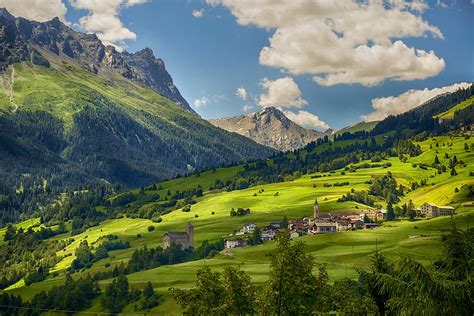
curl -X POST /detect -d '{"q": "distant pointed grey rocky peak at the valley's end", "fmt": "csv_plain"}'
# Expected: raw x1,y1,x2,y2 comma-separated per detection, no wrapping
209,107,326,151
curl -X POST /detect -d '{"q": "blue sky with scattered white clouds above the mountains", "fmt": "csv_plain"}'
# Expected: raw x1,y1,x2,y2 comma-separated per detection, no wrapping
0,0,474,130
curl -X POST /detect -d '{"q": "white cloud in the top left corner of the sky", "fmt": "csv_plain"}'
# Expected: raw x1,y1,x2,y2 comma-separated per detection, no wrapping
0,0,67,22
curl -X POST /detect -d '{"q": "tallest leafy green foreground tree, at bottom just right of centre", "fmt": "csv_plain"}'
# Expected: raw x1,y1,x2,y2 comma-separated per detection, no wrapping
260,232,330,315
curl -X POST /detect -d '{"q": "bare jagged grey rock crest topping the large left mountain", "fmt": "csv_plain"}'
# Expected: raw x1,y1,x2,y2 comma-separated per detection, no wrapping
0,8,194,112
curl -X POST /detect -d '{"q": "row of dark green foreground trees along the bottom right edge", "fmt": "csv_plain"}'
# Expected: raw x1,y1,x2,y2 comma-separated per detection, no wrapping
170,229,474,315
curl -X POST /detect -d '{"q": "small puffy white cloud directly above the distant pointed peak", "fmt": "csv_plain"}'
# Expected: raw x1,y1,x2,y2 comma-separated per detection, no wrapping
258,77,308,108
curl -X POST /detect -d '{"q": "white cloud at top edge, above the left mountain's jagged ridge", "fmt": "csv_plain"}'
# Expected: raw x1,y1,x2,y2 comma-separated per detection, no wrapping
69,0,147,51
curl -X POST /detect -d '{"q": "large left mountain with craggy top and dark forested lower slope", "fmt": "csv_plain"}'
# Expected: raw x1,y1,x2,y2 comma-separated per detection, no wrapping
0,10,274,193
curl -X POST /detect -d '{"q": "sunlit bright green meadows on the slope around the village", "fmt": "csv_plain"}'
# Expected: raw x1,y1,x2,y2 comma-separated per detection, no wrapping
4,136,474,312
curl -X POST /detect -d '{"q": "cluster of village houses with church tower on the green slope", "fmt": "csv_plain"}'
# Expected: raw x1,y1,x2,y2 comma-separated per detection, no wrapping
225,198,454,249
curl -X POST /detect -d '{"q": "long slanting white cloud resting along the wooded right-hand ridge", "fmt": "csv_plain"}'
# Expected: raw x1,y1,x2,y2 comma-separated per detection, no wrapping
361,82,471,121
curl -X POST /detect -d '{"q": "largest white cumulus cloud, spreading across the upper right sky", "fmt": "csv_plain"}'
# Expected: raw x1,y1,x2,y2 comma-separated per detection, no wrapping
206,0,445,86
